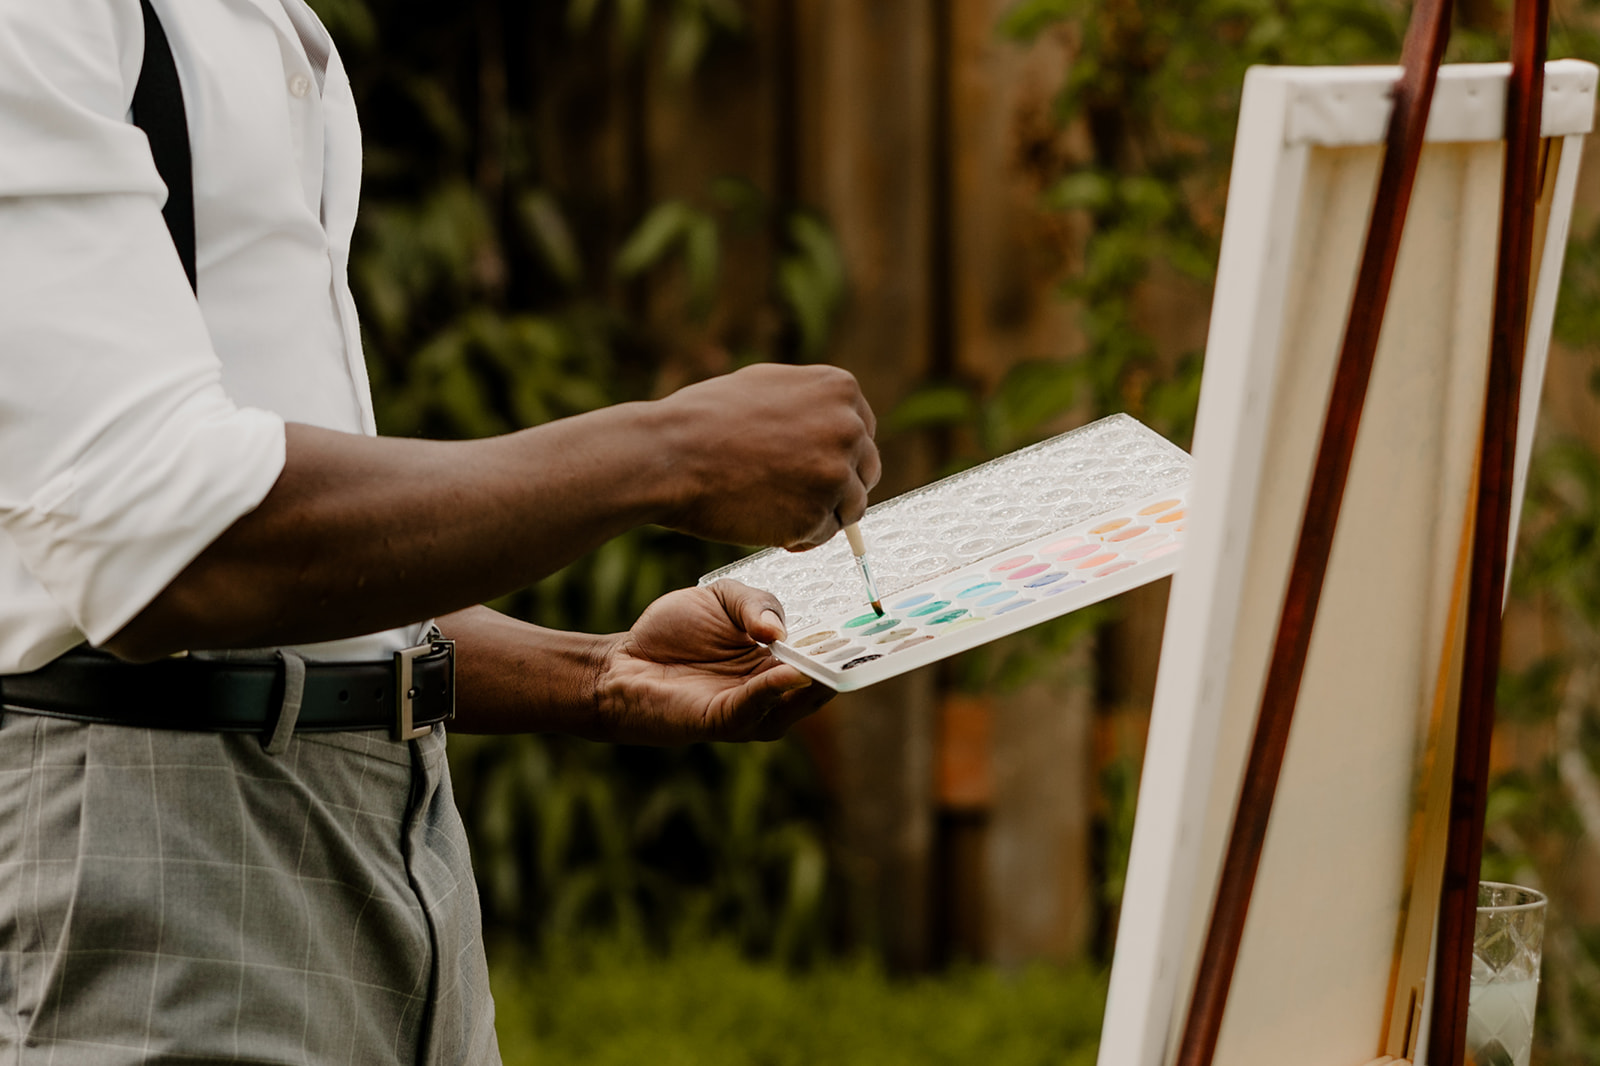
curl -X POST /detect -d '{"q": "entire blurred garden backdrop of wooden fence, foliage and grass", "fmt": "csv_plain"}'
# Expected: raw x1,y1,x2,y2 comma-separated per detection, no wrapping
312,0,1600,1066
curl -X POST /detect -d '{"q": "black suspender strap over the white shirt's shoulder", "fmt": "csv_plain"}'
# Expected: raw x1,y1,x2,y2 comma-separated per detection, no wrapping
133,0,200,293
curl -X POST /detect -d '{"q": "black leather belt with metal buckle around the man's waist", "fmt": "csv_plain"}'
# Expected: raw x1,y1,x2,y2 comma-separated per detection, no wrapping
0,640,456,739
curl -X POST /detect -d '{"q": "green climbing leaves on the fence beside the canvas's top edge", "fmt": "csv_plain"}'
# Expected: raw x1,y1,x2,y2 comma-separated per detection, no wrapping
1000,0,1403,437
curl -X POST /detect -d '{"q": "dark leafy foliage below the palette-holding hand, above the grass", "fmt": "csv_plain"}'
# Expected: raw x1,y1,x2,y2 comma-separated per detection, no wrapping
451,736,830,962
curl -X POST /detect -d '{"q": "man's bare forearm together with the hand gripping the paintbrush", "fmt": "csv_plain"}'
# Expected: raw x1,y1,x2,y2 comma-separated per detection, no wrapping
106,365,880,659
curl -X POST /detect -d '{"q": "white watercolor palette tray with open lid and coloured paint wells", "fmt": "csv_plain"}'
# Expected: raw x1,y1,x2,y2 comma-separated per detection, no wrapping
699,415,1190,691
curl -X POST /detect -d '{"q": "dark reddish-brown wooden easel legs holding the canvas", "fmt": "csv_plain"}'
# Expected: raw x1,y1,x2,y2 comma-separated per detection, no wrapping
1176,0,1549,1066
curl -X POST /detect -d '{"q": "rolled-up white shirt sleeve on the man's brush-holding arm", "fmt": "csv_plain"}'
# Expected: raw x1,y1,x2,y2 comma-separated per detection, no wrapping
0,0,283,643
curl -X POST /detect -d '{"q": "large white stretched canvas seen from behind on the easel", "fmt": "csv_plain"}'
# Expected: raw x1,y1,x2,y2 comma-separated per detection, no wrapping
1099,61,1595,1066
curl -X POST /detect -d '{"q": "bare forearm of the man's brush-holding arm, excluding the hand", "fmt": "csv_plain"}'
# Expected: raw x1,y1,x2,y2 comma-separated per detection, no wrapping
107,403,675,659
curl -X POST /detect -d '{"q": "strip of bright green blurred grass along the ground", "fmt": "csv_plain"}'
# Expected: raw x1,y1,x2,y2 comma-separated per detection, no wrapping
491,941,1106,1066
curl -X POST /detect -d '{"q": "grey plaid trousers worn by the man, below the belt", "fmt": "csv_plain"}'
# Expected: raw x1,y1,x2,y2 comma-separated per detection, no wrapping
0,712,499,1066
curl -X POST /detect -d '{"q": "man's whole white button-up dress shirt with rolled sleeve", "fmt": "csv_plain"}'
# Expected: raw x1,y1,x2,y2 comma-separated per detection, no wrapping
0,0,419,674
